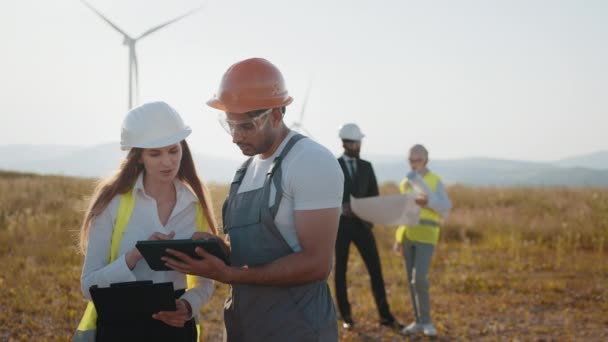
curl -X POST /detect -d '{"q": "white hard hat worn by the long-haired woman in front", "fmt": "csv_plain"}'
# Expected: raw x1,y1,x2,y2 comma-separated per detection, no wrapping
120,102,192,151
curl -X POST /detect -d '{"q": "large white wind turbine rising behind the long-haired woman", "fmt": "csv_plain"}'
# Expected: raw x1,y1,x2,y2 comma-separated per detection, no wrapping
81,0,201,110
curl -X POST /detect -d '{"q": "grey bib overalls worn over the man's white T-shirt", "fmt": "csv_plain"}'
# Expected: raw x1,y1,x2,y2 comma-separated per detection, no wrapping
223,134,338,342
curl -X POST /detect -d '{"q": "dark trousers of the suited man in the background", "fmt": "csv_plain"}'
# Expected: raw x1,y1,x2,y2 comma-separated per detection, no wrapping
334,216,394,321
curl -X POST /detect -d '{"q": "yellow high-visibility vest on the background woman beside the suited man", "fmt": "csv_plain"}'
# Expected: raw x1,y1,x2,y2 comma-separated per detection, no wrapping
395,171,441,245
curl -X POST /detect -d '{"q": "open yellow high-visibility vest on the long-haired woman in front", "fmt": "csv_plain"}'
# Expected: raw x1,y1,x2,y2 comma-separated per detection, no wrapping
72,189,208,342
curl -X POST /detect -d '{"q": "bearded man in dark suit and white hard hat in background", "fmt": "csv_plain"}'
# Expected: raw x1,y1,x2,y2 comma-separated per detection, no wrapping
334,123,400,329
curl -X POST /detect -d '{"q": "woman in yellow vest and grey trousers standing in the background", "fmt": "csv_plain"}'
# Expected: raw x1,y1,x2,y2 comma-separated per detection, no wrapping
395,145,452,336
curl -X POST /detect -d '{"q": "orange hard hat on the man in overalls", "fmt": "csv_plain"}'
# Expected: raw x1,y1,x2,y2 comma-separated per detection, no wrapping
207,58,293,113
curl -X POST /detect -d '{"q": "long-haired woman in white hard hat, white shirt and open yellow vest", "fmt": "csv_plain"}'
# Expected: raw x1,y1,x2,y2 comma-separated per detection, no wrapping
74,102,217,341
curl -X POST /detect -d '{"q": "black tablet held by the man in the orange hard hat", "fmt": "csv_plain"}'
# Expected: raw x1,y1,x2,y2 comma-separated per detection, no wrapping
135,239,230,271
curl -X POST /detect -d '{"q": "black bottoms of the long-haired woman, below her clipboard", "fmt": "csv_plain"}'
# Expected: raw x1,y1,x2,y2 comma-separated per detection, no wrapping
95,290,197,342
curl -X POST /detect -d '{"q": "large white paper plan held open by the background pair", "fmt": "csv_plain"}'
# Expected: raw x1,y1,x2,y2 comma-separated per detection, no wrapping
350,194,420,226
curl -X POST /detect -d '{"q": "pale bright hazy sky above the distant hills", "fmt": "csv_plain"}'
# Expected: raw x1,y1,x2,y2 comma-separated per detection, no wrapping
0,0,608,160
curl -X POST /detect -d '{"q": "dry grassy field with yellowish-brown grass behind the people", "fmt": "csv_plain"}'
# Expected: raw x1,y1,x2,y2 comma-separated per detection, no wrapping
0,172,608,341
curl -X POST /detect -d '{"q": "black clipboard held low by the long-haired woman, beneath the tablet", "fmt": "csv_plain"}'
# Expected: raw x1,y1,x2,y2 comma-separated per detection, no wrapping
89,280,177,324
